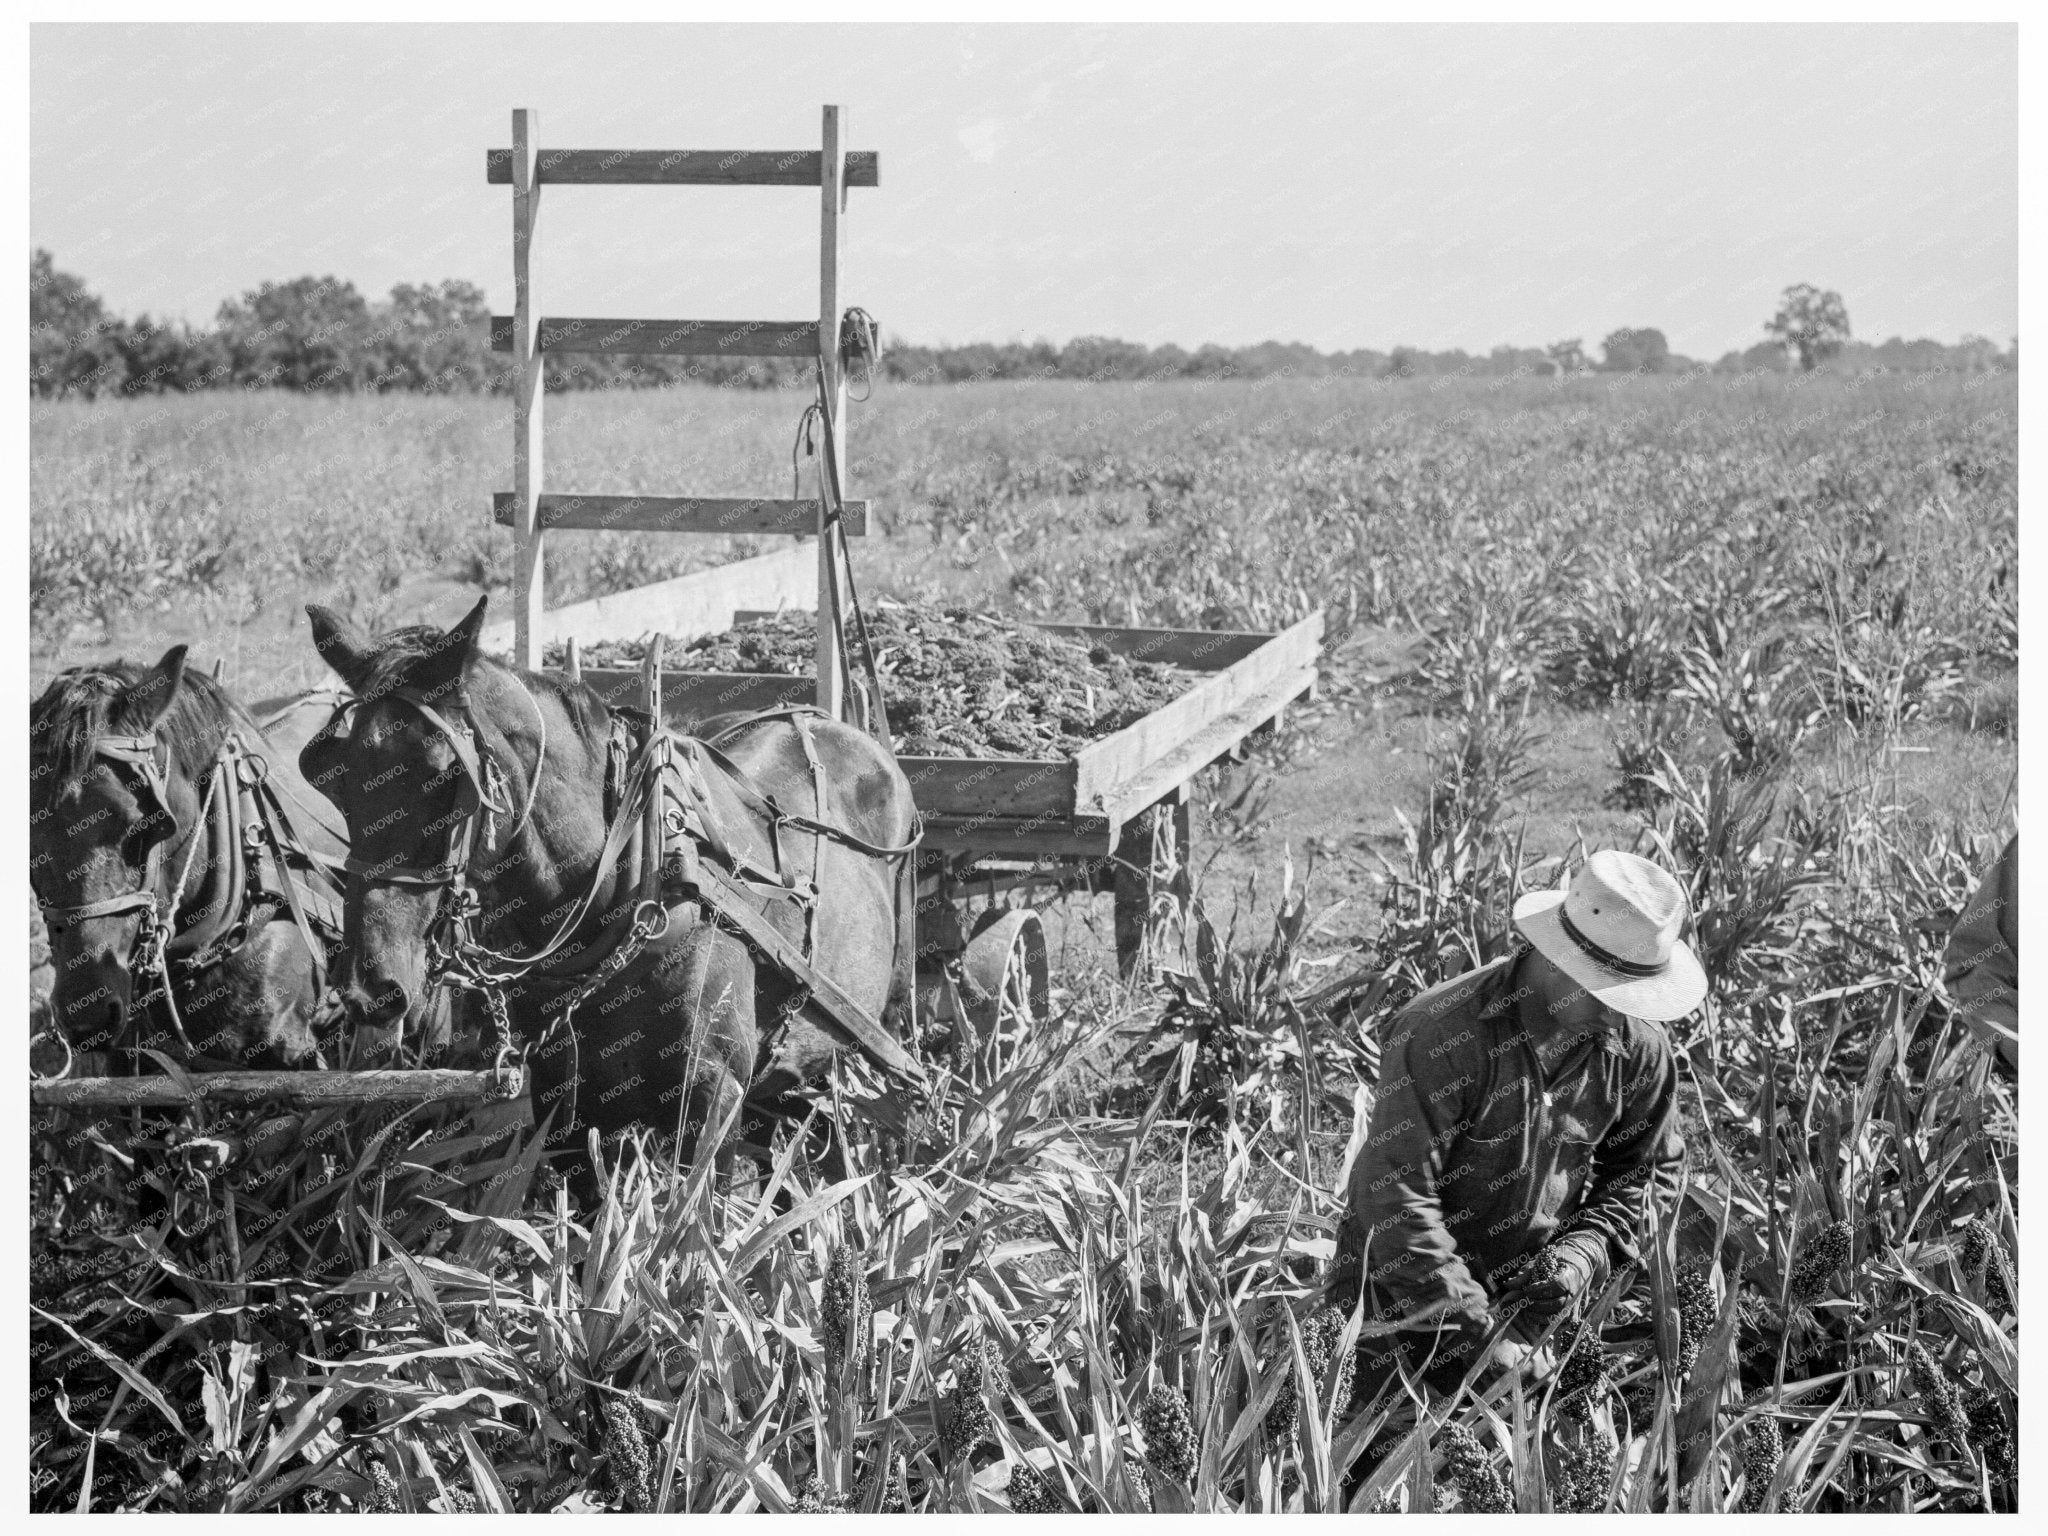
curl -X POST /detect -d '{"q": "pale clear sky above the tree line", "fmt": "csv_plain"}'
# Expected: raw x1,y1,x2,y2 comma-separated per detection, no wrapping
29,25,2017,358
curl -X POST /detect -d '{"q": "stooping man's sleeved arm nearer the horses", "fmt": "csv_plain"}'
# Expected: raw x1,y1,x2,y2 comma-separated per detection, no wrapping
1333,1020,1491,1335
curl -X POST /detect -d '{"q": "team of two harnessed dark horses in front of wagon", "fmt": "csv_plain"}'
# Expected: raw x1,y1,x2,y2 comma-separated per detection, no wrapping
29,602,922,1188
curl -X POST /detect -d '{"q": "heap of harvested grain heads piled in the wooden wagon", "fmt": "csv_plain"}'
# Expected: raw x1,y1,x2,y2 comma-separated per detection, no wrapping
547,604,1198,758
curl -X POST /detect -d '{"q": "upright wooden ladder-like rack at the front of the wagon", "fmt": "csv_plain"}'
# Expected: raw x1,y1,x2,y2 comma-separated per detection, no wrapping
485,106,881,719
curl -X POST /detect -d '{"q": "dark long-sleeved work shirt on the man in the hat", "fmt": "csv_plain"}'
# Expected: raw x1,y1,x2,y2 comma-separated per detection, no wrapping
1331,956,1683,1333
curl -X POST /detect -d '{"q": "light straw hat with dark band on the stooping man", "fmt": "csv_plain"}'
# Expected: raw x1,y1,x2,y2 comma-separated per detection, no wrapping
1513,848,1706,1022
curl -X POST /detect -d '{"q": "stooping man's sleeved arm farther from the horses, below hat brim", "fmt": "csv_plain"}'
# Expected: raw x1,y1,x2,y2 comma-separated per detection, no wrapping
1554,1026,1686,1298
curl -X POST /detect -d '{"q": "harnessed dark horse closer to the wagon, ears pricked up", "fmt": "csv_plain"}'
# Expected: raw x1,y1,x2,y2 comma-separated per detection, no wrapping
301,602,915,1190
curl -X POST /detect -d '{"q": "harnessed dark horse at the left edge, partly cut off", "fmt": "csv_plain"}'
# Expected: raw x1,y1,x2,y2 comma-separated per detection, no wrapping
29,645,346,1069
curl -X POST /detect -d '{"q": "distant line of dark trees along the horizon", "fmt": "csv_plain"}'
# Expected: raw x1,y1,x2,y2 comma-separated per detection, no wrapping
29,250,2019,397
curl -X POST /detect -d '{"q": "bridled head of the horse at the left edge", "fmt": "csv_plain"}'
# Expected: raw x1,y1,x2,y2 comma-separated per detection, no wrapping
29,645,218,1051
